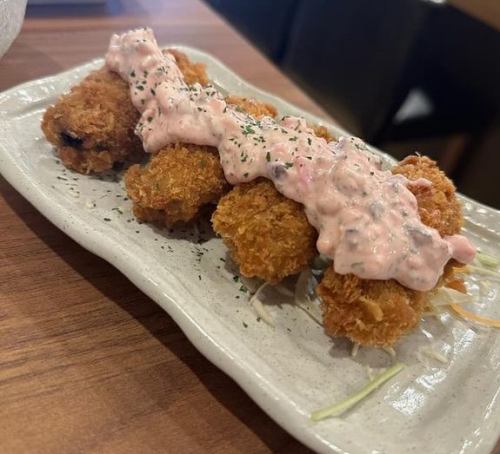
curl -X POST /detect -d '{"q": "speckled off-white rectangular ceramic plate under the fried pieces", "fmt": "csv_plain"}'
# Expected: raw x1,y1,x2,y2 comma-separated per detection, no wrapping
0,47,500,453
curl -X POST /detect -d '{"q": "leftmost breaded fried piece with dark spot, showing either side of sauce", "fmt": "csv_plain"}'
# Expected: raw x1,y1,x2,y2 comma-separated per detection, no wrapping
42,49,208,173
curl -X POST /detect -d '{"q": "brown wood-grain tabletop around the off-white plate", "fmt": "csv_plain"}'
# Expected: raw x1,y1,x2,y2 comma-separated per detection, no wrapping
0,0,500,453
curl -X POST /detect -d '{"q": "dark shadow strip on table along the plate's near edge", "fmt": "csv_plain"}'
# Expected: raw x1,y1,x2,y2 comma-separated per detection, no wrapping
0,177,310,453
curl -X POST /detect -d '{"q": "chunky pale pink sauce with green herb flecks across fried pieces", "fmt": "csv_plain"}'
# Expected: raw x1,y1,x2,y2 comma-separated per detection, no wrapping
106,29,475,291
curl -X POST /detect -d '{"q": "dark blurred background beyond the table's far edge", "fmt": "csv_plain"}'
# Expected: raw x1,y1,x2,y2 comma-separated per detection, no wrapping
27,0,500,208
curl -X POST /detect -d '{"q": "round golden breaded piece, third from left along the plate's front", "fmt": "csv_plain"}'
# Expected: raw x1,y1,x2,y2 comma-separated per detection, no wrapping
212,179,317,283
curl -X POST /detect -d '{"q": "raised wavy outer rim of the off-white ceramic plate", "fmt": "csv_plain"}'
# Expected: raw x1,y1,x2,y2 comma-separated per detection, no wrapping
0,49,500,454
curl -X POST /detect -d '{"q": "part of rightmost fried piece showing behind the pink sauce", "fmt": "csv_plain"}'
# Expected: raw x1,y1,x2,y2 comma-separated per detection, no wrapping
392,156,463,236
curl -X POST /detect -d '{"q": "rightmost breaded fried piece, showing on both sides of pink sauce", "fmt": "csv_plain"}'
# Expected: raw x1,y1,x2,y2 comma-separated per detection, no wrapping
316,156,462,347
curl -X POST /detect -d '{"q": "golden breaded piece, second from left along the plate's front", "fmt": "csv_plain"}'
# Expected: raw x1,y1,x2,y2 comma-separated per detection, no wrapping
125,145,228,226
